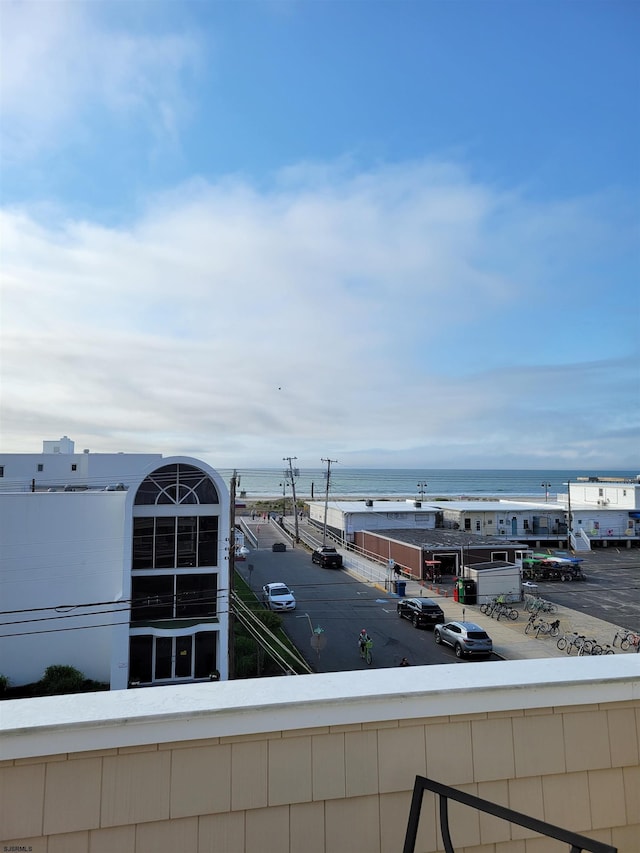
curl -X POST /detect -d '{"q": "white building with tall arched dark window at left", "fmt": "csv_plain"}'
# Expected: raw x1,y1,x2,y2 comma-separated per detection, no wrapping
0,437,230,689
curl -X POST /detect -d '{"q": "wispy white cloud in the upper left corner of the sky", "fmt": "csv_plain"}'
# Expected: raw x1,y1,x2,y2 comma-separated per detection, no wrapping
0,0,201,161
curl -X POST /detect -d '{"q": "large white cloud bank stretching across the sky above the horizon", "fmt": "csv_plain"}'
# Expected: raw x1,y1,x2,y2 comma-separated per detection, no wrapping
2,163,638,466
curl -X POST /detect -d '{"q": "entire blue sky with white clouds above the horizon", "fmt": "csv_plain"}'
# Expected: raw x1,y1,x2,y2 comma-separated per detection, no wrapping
0,0,640,469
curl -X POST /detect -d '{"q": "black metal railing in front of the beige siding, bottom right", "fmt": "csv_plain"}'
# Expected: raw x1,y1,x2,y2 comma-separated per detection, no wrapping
402,776,618,853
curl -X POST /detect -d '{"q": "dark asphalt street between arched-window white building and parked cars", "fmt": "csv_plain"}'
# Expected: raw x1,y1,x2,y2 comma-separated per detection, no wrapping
236,547,500,672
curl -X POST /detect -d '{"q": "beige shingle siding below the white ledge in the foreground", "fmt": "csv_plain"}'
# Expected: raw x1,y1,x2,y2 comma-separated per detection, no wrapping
0,702,640,853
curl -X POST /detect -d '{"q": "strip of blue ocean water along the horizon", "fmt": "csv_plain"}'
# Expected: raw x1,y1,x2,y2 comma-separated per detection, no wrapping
220,465,640,500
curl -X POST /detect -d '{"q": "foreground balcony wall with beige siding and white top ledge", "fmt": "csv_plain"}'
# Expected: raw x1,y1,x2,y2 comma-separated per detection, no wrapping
0,655,640,853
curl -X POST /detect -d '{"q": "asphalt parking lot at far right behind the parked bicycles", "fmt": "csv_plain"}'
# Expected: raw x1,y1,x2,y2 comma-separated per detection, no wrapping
520,548,640,633
